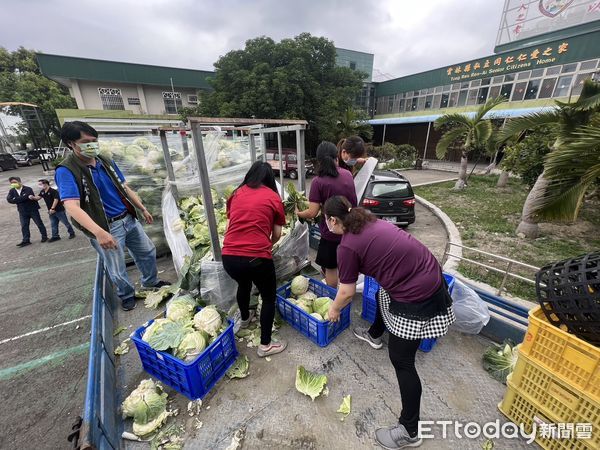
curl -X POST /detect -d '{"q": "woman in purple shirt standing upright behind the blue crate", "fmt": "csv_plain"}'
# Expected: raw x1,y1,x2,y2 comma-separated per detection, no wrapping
296,142,356,288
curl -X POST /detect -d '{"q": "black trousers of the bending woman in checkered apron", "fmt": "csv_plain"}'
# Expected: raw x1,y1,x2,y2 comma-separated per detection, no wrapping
369,294,423,437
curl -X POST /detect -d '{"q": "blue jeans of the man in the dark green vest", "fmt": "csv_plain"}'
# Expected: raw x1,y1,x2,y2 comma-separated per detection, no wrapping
90,216,158,300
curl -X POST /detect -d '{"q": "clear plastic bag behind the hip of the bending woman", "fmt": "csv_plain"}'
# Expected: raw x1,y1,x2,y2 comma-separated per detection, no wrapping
452,279,490,334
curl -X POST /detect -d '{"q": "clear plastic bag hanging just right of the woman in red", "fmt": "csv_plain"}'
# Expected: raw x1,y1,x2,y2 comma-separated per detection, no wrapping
273,222,308,280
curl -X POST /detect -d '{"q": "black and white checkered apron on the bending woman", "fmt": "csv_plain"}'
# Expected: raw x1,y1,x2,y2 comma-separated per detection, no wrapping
377,287,456,339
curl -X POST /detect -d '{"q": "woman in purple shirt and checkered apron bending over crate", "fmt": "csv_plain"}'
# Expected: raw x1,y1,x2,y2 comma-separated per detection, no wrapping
324,196,454,449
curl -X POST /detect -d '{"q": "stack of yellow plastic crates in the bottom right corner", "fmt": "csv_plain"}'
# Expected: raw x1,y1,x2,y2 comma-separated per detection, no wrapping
498,307,600,450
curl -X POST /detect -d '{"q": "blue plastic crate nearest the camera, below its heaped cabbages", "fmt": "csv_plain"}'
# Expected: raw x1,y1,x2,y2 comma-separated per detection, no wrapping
131,310,238,400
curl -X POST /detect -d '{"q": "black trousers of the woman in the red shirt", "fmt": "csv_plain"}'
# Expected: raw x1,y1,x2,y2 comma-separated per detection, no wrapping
223,255,277,345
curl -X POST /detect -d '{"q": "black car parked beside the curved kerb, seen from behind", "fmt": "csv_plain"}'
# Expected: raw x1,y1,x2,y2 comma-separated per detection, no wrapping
360,171,415,227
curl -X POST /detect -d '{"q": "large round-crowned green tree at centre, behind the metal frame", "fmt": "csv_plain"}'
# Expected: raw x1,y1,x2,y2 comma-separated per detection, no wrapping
184,33,364,146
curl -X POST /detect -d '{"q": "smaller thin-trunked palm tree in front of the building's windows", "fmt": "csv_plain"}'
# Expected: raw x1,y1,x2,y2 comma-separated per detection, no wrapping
434,96,506,189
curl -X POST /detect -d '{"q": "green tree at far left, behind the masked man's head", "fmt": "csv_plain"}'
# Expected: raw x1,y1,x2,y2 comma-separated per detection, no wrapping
0,47,77,142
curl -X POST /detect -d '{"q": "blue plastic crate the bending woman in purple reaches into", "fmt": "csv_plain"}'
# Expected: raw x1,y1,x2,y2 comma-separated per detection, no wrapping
277,278,351,347
